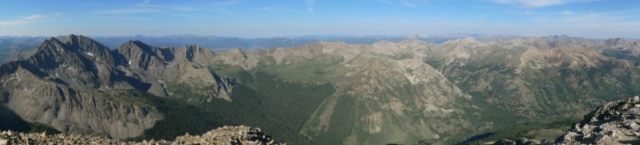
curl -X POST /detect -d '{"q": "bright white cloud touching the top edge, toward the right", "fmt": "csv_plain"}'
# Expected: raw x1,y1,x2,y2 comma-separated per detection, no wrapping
492,0,600,8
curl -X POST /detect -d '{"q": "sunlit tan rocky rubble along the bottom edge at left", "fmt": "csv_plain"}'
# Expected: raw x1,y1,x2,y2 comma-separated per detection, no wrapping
0,126,280,145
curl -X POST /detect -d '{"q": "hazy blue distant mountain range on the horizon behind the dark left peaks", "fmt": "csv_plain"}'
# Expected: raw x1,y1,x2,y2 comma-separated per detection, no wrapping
0,34,488,60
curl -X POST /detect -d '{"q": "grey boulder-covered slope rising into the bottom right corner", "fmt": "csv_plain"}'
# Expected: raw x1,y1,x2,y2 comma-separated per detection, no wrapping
492,96,640,145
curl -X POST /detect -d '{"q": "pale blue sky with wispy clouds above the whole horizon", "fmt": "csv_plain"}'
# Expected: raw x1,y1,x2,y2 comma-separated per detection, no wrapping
0,0,640,38
